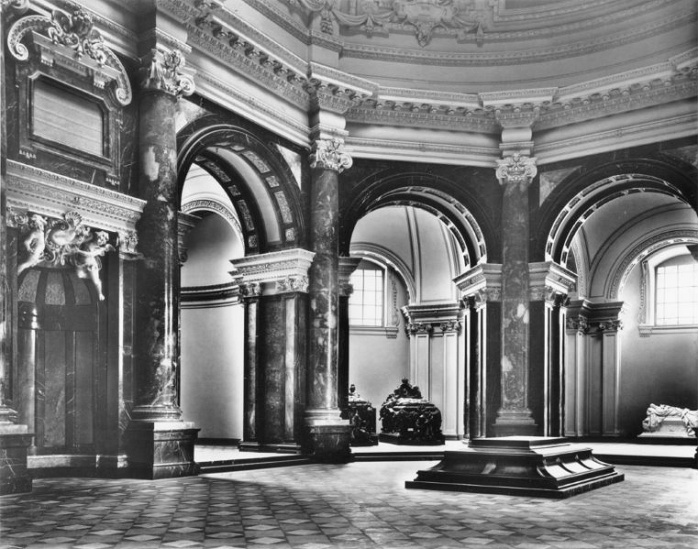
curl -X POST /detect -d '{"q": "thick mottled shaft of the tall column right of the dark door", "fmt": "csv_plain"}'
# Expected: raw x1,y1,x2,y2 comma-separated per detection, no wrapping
131,91,180,419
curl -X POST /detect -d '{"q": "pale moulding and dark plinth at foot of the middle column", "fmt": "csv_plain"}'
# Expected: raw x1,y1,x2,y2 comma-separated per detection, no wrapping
304,409,353,463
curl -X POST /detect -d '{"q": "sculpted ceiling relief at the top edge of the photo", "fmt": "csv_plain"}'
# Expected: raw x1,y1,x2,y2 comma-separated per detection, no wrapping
286,0,484,47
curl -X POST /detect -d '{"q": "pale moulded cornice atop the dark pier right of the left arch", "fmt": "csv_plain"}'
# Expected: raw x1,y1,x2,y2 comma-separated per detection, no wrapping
230,248,315,296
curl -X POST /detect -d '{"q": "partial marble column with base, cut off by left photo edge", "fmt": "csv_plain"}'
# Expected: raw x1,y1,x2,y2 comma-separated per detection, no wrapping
0,2,33,495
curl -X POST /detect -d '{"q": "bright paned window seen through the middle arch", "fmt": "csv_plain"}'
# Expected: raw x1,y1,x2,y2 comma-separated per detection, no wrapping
349,260,386,326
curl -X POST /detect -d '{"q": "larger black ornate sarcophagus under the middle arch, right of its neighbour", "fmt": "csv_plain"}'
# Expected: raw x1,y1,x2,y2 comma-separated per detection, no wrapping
379,379,444,445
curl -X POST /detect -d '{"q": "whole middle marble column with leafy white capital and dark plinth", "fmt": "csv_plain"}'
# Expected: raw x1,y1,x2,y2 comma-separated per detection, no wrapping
306,139,351,462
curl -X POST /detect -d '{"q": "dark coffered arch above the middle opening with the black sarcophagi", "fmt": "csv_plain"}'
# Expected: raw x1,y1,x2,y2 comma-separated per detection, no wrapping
340,173,496,267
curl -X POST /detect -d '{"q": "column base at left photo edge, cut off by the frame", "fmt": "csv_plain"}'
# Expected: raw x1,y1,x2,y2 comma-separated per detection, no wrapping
0,423,34,495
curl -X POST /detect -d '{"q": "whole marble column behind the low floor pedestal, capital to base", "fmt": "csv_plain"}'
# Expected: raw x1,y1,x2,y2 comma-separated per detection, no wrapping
495,153,538,436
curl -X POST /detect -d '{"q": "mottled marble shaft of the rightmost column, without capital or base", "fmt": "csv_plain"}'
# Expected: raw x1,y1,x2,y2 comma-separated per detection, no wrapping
500,180,529,414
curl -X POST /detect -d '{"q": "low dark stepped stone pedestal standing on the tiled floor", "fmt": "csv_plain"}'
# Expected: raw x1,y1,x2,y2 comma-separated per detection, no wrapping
405,436,624,498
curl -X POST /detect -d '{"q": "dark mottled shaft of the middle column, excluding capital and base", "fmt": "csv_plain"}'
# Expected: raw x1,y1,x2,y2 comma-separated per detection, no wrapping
308,168,339,409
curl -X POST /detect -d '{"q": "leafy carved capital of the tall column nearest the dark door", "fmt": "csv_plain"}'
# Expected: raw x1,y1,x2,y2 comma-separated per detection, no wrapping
138,46,195,98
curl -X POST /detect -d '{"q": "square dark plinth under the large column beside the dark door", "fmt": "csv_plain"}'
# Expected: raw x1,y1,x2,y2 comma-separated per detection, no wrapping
126,420,200,479
